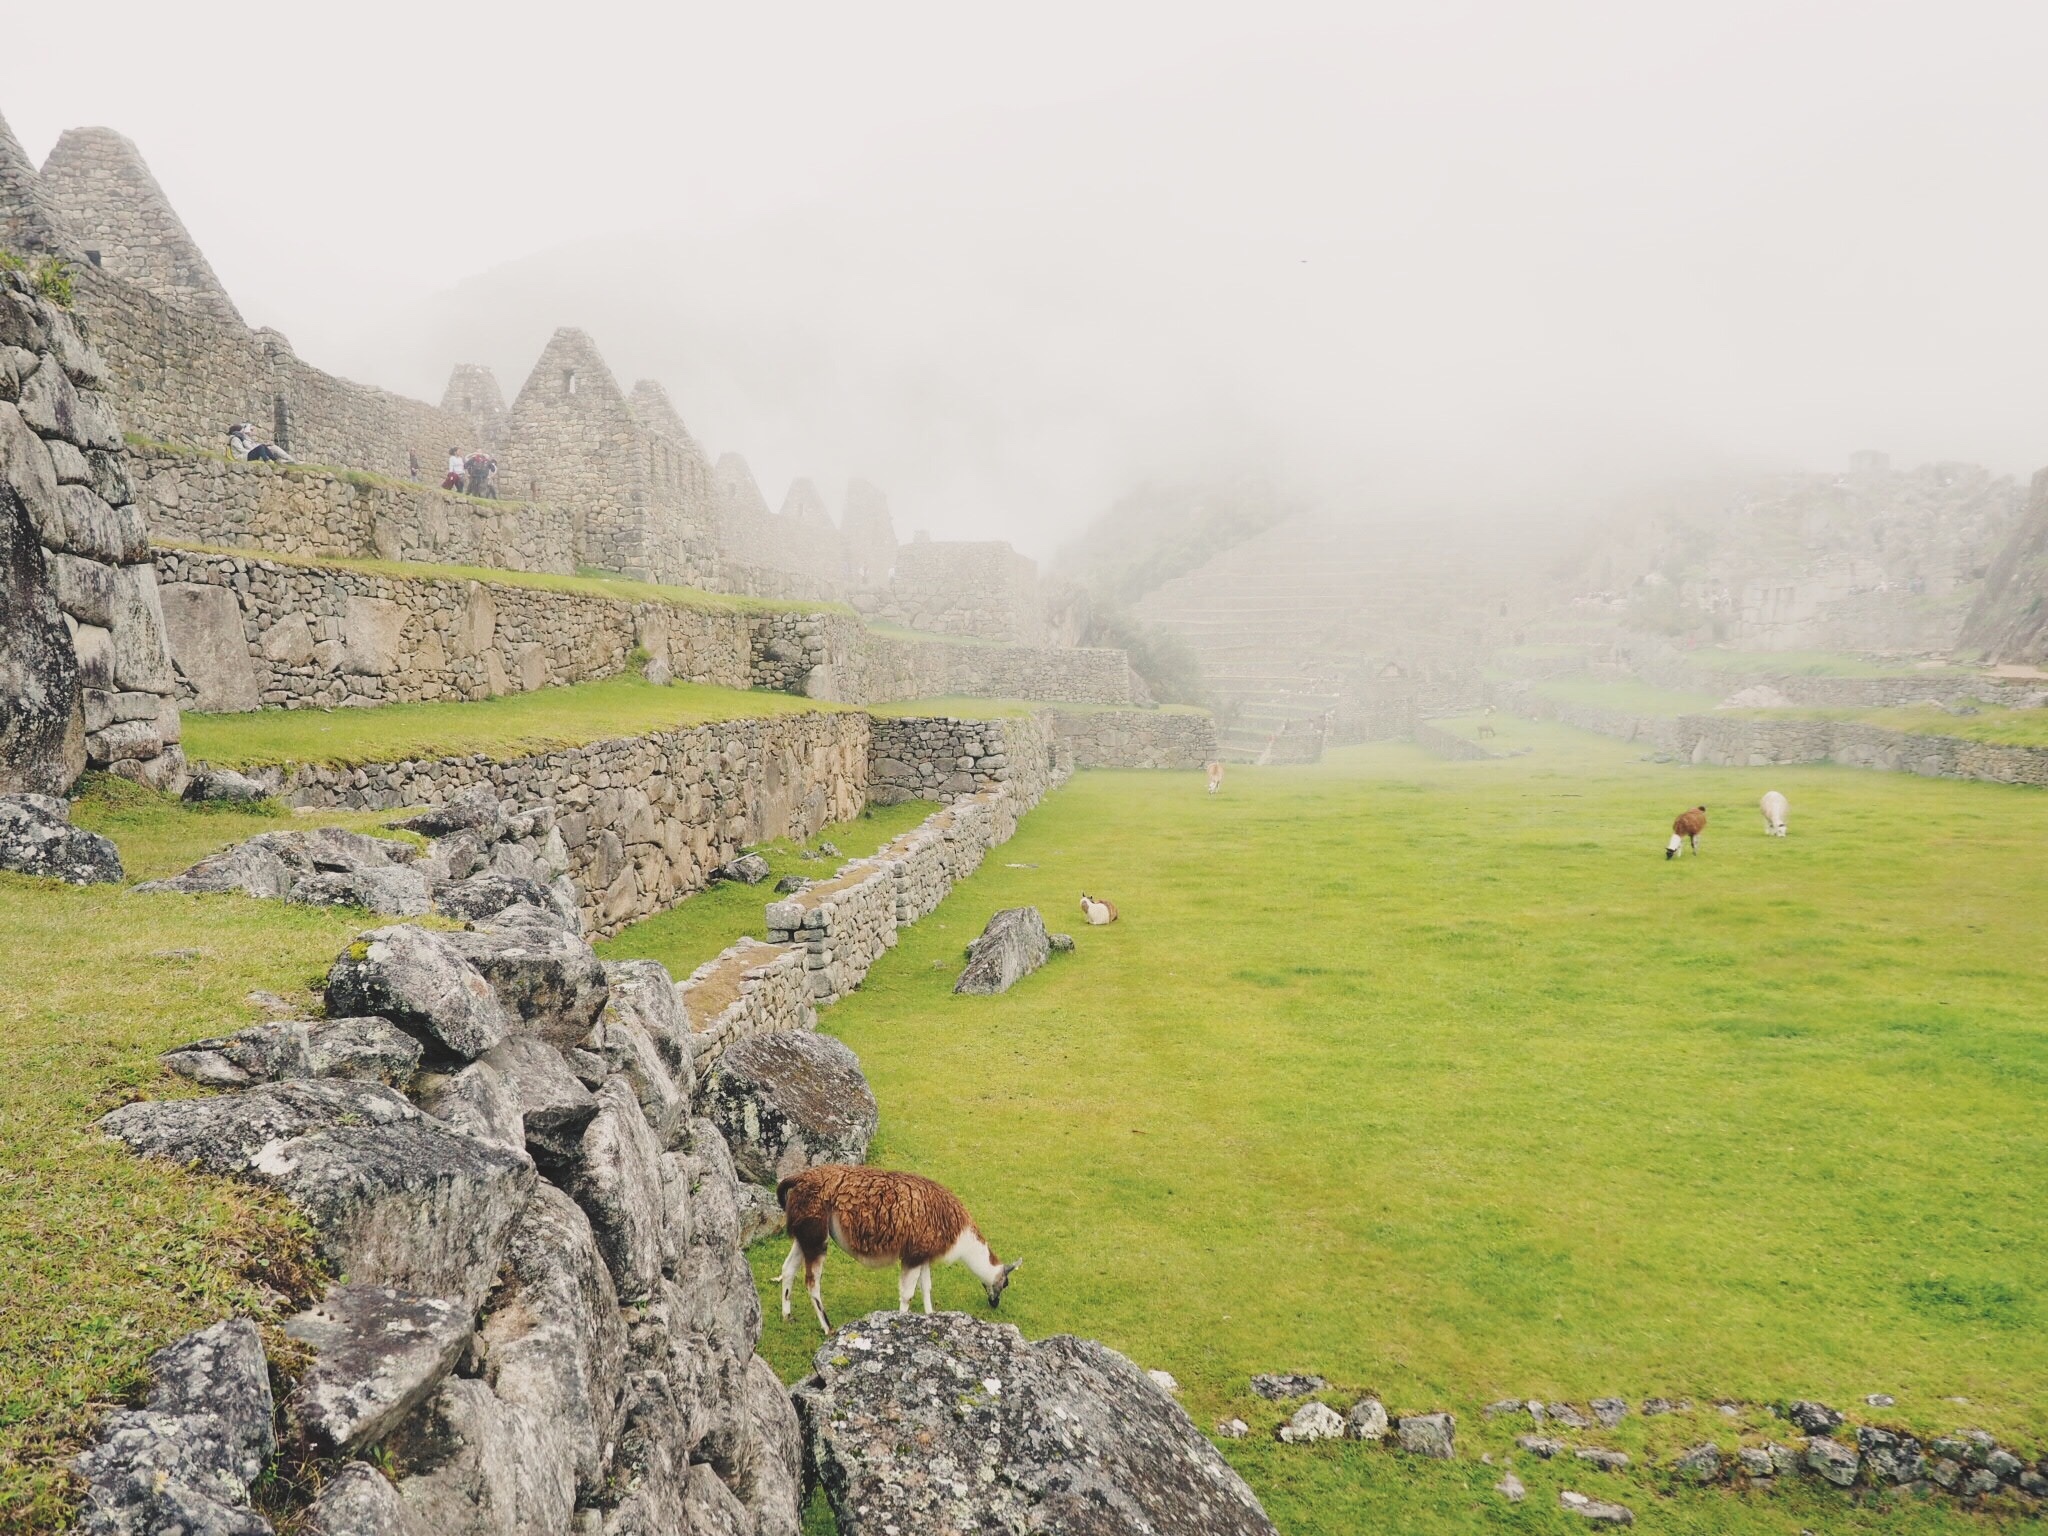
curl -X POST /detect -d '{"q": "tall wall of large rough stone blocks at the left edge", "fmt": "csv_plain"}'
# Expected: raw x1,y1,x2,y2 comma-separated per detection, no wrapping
0,270,184,795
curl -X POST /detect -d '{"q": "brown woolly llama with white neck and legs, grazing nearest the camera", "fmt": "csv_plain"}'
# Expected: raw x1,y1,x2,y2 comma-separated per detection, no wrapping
774,1163,1024,1333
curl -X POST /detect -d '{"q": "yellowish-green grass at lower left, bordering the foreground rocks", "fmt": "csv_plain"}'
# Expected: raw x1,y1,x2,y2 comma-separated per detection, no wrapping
0,778,423,1532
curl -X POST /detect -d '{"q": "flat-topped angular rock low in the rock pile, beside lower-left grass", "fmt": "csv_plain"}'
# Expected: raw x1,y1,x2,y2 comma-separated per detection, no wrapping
285,1284,475,1456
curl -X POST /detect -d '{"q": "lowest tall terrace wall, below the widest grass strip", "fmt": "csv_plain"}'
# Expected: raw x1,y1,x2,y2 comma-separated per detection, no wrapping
276,713,868,936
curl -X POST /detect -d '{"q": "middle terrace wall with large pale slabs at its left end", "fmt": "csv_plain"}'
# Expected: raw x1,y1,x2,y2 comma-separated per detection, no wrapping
156,549,750,713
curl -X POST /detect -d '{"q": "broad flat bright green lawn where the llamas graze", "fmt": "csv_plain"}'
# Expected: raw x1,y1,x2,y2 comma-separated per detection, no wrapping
754,723,2048,1536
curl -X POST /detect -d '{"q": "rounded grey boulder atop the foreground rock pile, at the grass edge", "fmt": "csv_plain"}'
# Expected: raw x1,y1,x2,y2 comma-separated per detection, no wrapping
328,924,510,1061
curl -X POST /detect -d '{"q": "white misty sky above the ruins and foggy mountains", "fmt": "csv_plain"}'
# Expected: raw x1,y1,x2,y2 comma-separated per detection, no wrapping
0,0,2048,555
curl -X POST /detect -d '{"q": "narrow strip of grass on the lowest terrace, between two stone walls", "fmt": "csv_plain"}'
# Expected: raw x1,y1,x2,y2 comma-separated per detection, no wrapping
184,674,840,768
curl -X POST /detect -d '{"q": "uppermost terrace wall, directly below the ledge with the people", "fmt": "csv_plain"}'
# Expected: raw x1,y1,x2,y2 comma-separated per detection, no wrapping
127,449,578,575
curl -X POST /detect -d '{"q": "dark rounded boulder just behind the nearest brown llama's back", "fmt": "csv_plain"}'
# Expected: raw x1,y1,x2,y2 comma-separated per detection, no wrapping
705,1030,881,1184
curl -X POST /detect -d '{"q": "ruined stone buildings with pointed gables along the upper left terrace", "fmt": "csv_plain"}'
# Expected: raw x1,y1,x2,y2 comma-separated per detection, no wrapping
0,107,1042,643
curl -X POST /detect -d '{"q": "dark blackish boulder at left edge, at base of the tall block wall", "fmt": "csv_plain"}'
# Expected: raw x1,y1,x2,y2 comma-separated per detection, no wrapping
0,481,86,795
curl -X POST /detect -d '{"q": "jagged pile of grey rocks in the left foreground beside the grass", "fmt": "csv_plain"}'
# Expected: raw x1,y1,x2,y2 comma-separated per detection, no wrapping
82,913,801,1536
